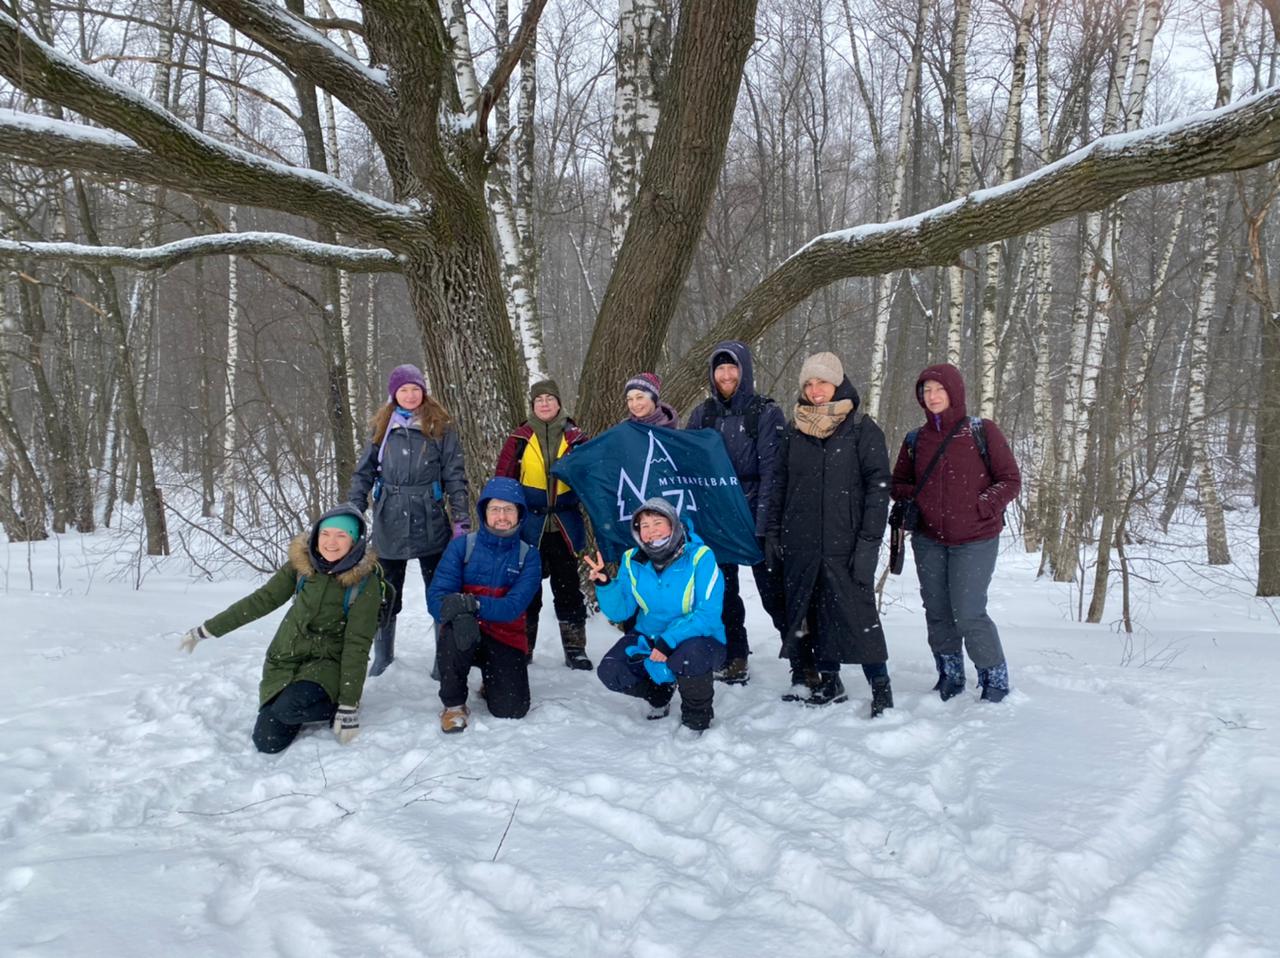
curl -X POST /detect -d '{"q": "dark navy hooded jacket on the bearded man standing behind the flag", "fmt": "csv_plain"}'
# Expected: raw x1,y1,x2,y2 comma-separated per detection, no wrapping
685,339,787,538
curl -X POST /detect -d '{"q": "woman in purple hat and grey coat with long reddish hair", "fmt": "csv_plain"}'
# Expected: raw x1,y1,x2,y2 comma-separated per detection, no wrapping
347,364,471,675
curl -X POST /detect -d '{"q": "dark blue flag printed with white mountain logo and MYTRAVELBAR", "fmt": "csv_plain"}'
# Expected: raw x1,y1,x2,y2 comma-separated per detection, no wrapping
552,421,763,565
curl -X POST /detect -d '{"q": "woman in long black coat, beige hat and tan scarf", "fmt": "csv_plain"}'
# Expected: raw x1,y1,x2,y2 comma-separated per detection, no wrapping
765,352,893,717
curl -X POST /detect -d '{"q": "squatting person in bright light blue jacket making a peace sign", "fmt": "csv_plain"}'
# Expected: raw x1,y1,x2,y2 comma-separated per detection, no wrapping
586,496,724,733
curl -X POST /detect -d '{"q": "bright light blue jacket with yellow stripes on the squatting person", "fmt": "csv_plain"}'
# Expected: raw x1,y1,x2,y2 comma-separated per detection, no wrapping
595,532,724,648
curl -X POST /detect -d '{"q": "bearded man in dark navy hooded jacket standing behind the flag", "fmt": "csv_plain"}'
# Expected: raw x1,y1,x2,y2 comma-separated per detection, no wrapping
685,339,787,685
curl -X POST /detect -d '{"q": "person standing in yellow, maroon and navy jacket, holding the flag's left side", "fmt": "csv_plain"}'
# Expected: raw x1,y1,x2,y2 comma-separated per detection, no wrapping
494,379,591,671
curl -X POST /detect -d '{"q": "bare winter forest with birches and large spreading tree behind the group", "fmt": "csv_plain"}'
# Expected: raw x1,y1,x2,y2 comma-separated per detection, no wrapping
0,0,1280,614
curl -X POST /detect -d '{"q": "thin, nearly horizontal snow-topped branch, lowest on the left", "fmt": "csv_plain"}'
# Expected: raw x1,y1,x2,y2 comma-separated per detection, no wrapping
0,231,401,273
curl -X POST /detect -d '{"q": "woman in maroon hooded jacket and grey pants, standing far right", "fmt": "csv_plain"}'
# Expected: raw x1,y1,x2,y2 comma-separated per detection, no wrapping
892,364,1023,702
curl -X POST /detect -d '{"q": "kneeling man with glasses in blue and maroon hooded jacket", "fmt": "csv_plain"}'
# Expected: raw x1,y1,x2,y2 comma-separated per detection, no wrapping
426,476,543,733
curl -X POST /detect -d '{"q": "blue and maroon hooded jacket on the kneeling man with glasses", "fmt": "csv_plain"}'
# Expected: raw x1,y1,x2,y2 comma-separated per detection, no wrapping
426,478,543,652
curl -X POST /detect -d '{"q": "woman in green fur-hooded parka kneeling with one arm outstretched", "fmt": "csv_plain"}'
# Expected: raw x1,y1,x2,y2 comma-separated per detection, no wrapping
179,506,383,753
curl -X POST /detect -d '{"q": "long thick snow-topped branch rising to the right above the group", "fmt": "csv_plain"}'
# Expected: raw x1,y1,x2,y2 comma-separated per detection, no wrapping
663,87,1280,409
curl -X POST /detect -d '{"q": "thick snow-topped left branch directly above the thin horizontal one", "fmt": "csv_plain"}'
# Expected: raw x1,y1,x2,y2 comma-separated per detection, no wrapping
0,107,417,248
